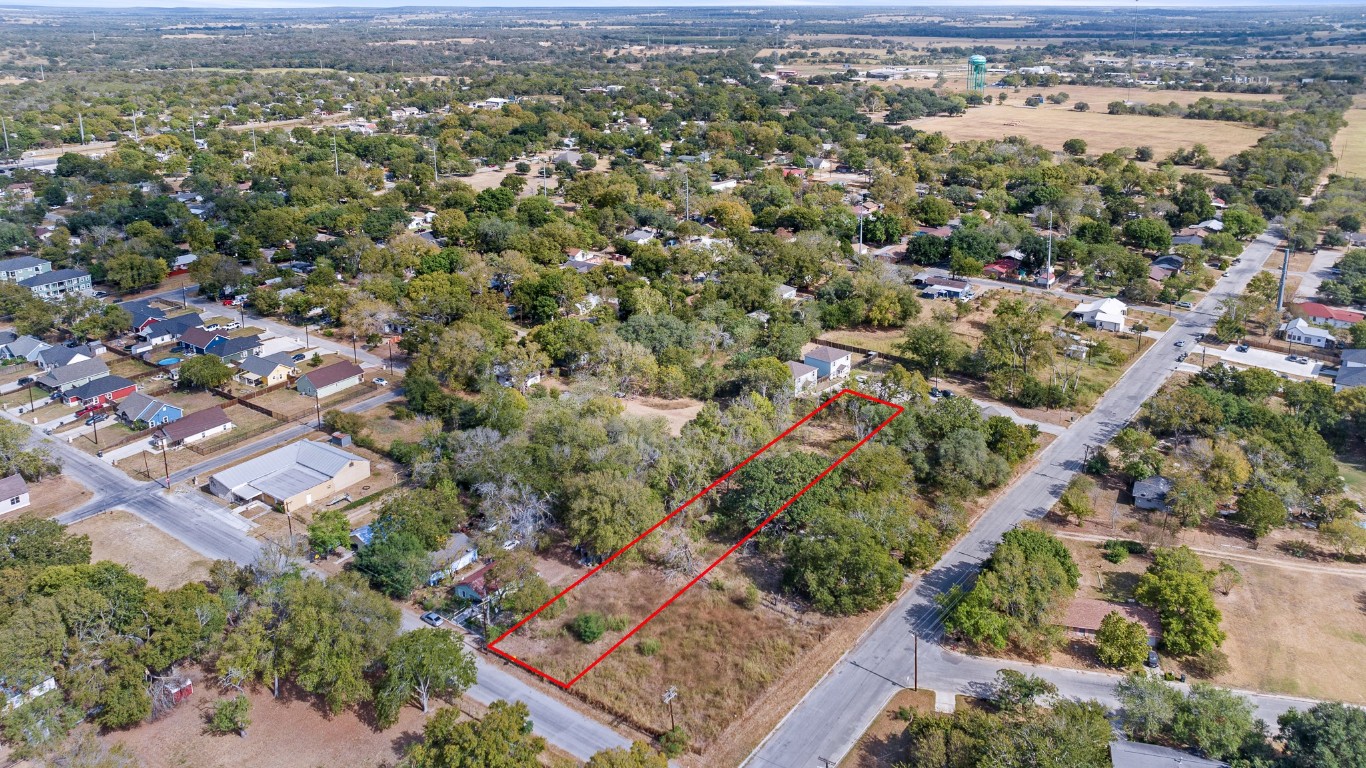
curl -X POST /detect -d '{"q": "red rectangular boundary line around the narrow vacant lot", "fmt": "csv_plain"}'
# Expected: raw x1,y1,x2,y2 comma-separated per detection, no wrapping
488,389,906,690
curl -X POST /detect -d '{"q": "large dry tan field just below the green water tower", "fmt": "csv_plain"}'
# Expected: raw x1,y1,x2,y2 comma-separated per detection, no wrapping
910,103,1266,160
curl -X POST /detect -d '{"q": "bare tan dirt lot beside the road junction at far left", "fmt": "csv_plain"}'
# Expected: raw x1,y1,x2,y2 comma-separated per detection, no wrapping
68,510,212,589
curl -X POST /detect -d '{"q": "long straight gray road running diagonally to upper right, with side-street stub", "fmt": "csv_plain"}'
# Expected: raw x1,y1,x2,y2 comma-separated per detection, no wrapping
746,234,1277,768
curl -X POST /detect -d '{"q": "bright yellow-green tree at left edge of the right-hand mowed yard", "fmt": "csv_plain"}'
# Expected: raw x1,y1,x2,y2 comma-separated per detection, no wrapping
1134,547,1224,656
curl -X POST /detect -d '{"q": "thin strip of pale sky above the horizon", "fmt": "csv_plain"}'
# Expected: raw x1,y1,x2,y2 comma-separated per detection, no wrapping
18,0,1366,11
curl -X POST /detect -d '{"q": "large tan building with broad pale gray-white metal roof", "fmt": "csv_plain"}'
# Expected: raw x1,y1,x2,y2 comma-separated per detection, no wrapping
209,440,370,512
